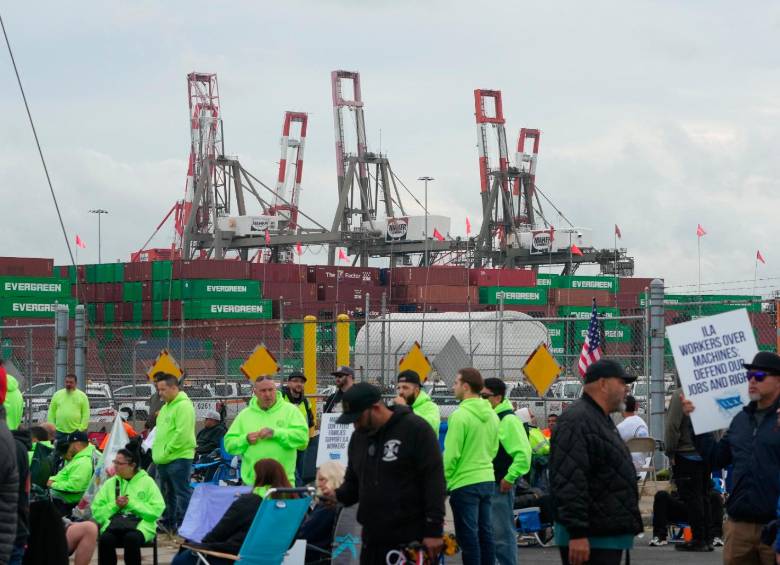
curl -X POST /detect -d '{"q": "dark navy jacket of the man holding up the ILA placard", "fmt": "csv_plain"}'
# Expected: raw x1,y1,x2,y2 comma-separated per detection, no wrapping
694,401,780,524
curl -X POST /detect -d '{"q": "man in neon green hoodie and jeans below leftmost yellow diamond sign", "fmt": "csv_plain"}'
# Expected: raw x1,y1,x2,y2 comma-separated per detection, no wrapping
152,372,196,532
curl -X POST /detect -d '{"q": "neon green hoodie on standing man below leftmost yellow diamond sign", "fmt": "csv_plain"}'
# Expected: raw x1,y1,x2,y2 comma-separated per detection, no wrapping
152,390,197,465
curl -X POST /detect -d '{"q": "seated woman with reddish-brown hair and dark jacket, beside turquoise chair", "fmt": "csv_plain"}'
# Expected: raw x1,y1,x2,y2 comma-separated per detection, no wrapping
171,459,292,565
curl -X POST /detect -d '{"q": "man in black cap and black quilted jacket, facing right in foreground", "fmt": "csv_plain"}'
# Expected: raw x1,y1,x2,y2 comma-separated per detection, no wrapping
550,358,644,565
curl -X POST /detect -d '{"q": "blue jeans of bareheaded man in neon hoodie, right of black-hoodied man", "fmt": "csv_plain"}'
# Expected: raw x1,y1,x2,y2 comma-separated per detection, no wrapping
450,481,496,565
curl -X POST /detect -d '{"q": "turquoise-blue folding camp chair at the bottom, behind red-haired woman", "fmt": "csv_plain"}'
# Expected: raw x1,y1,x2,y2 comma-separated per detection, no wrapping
182,487,314,565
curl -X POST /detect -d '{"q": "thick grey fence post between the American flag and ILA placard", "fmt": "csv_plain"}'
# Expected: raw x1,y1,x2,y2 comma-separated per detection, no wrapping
650,279,665,467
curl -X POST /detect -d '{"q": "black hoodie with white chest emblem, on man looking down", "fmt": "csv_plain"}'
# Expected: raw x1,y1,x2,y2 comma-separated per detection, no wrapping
336,406,446,544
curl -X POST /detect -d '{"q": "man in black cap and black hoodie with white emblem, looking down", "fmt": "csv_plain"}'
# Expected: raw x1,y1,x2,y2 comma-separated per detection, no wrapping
319,383,446,565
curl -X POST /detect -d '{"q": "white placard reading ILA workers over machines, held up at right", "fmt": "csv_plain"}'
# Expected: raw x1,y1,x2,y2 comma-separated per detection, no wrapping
666,309,758,434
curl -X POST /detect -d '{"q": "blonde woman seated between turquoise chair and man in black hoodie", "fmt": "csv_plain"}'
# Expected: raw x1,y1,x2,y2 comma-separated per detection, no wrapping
296,461,346,563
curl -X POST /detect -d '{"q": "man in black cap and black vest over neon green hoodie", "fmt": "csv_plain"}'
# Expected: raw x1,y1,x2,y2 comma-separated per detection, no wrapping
482,378,531,565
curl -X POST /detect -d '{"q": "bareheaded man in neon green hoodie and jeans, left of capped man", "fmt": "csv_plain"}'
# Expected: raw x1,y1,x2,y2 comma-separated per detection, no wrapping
444,368,499,565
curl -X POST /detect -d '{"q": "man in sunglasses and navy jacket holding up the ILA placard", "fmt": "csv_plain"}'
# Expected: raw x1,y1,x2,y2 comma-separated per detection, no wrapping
683,351,780,565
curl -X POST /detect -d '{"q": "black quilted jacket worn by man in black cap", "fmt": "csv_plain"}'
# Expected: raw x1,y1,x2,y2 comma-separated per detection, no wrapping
550,393,643,539
